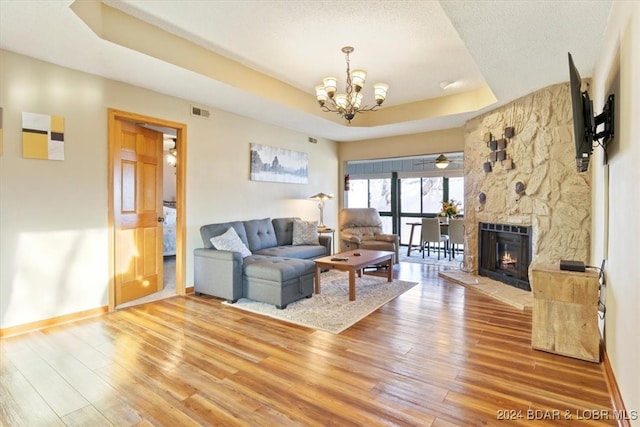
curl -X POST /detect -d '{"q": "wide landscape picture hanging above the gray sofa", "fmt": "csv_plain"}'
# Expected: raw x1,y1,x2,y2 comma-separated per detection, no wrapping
250,143,309,184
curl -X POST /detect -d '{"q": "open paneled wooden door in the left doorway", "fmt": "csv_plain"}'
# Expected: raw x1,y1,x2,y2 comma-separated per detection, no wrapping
113,120,163,306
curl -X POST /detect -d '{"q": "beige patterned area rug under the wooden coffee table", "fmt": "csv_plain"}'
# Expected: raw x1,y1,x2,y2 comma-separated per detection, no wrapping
222,270,417,334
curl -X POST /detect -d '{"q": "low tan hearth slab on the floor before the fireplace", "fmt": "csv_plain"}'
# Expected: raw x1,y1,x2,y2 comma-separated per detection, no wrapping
438,269,533,310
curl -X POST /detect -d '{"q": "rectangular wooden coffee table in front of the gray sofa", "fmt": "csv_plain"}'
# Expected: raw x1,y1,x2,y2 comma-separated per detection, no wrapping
314,249,393,301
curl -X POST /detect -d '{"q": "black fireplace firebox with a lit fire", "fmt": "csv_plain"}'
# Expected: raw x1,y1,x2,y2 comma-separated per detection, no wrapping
478,222,531,291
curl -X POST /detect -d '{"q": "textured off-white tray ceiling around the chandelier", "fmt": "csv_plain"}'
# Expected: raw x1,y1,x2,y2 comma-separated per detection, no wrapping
0,0,611,141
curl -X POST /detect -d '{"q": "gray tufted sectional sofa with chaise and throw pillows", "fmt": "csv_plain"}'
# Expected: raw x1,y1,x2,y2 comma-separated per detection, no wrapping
194,218,332,309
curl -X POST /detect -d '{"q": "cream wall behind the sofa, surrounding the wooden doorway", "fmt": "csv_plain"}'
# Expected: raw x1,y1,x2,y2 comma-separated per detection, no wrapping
0,50,339,329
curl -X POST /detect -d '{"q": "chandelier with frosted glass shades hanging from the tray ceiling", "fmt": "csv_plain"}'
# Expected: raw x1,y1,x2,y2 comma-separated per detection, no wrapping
316,46,389,123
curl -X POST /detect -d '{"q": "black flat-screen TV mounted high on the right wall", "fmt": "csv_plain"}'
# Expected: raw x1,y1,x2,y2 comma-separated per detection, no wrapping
569,53,594,172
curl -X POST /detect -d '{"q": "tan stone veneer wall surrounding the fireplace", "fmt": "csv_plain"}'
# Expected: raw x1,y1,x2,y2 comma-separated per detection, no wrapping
464,83,597,278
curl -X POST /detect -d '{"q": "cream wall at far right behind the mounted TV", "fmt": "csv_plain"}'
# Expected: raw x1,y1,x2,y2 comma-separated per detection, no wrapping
590,2,640,425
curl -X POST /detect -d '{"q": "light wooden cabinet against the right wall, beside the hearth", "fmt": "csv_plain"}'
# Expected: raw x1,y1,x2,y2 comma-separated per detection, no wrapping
531,265,600,362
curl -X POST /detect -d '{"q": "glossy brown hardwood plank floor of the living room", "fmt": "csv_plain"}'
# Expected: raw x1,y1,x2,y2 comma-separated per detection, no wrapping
0,263,616,426
